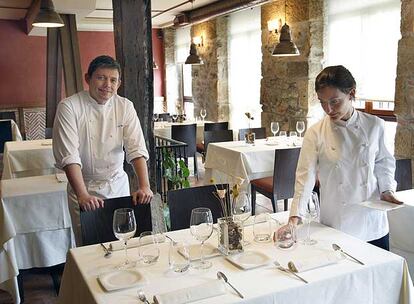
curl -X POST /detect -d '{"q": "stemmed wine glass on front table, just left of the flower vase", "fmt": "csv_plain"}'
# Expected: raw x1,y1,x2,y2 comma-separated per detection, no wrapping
190,208,213,269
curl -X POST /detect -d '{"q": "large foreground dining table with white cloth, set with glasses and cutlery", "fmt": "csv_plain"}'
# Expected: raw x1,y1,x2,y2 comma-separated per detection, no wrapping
58,212,414,304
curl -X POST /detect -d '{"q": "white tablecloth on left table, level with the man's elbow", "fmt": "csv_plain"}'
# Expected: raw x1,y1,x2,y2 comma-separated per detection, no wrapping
2,139,55,179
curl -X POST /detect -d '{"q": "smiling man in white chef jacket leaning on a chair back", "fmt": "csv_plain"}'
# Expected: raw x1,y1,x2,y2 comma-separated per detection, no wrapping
53,56,153,245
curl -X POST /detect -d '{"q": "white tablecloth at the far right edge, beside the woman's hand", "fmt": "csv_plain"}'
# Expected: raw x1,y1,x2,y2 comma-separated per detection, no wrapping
388,190,414,279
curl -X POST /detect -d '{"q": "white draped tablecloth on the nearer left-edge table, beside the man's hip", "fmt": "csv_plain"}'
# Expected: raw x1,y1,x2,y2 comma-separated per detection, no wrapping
0,175,75,303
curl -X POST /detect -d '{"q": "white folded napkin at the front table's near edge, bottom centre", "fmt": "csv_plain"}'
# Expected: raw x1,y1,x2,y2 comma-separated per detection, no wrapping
154,280,226,304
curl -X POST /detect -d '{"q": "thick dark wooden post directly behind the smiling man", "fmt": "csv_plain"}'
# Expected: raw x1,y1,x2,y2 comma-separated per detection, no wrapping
112,0,156,192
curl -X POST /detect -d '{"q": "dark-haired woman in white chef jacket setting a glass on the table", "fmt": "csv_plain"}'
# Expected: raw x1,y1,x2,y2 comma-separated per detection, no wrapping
289,66,401,250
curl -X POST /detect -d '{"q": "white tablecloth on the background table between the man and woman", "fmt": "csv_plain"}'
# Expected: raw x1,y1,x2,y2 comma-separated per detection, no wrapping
204,139,300,188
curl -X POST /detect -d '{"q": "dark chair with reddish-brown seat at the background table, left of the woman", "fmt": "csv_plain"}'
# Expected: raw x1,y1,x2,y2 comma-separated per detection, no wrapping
250,148,300,214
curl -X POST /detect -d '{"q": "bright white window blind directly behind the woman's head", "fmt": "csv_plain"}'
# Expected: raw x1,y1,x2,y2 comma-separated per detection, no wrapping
325,0,401,101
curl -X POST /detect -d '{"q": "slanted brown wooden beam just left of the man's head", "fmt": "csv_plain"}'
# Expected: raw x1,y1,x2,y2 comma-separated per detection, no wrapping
59,14,83,96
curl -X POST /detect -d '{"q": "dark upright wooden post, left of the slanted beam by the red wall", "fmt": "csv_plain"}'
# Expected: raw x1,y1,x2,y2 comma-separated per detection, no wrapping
46,28,62,128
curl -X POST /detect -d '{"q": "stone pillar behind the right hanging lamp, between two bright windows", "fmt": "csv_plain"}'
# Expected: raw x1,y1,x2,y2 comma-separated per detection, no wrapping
260,0,323,134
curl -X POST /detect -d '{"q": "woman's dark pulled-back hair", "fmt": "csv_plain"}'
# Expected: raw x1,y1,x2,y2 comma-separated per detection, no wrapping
315,65,356,94
